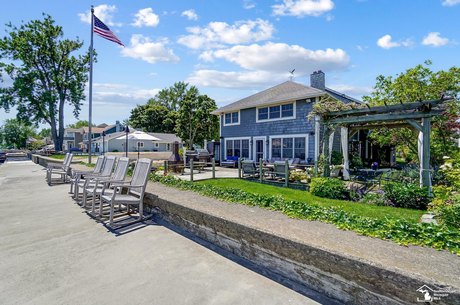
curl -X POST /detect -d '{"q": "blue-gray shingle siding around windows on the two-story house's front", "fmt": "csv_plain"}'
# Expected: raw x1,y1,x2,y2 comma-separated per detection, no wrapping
221,100,315,160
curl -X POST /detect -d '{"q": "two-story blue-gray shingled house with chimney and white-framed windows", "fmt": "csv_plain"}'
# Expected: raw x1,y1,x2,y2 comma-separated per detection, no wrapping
213,71,360,163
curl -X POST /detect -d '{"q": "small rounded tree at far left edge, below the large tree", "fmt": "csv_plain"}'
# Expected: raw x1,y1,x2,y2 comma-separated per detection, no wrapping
0,119,35,148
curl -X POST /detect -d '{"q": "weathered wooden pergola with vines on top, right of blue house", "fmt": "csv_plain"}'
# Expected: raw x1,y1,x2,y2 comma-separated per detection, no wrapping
321,98,451,189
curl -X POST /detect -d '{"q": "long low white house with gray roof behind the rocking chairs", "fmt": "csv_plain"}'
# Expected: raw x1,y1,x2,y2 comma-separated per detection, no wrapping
94,128,182,152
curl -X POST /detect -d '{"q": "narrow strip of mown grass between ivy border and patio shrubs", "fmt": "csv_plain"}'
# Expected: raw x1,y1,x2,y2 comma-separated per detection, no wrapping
197,179,424,223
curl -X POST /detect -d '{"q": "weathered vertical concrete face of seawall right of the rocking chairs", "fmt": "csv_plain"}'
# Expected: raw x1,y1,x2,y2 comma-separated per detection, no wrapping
144,193,460,305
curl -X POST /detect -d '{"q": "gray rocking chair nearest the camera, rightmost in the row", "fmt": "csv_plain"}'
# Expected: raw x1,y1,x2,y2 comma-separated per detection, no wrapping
101,158,152,227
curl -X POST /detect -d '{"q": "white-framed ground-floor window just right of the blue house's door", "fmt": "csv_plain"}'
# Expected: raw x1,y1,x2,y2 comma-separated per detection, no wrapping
269,134,309,160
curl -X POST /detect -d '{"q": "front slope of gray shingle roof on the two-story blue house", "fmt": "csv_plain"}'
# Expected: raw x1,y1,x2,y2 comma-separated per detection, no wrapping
212,81,326,114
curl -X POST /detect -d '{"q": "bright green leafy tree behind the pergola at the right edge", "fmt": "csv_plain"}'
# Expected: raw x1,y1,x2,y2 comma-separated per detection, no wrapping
363,61,460,164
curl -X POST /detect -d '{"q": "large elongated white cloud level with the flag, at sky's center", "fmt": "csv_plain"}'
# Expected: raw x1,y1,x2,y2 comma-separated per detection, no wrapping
178,19,275,49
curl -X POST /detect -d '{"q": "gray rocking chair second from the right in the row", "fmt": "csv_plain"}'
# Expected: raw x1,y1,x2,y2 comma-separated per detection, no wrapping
83,157,129,213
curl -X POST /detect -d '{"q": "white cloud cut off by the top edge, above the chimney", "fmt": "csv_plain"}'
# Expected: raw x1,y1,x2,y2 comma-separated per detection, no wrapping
272,0,334,17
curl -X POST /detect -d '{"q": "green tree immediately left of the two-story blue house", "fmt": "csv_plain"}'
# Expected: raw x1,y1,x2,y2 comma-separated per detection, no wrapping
175,86,219,148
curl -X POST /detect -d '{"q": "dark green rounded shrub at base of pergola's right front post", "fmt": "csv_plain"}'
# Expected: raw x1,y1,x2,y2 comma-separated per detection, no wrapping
384,183,430,210
